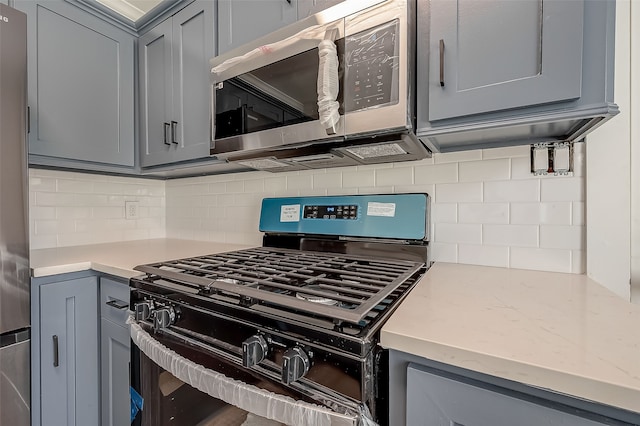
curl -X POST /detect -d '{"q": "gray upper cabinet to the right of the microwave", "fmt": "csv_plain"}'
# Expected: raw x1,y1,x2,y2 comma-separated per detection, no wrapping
416,0,618,152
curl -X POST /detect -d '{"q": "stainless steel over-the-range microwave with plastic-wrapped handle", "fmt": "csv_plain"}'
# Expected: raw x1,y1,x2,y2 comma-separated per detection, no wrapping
210,0,430,171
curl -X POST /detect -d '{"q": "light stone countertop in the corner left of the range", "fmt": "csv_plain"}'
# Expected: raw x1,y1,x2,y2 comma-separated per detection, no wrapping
30,238,250,278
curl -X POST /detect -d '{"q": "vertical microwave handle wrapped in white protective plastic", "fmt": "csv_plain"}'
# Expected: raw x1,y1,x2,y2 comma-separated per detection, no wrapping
317,37,340,135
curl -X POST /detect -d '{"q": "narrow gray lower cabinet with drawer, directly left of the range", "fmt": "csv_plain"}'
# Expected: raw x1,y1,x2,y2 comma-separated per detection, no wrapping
100,277,131,426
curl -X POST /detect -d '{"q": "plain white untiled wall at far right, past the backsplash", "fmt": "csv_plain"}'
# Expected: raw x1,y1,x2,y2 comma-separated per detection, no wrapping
586,0,640,300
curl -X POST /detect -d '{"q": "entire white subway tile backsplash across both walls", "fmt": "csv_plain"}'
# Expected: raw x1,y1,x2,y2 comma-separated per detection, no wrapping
29,146,585,273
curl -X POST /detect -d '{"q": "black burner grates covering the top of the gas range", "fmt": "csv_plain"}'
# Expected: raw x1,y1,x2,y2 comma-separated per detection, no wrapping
135,247,424,323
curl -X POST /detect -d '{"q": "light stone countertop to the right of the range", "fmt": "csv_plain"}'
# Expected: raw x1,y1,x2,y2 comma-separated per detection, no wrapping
381,263,640,413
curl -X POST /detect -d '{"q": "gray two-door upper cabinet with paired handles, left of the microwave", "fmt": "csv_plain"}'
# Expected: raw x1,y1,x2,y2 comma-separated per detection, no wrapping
138,1,215,167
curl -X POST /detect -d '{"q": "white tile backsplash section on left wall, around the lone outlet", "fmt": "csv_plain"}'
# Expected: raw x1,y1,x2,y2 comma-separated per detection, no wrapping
29,169,165,249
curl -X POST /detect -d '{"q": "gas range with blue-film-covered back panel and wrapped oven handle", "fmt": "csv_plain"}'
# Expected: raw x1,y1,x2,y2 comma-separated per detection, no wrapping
130,194,429,426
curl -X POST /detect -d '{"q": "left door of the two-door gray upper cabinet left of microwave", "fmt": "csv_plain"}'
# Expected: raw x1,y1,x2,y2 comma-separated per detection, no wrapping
138,19,172,166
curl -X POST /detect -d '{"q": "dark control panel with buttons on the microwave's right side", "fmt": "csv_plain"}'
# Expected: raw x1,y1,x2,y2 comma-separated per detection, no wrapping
344,20,399,112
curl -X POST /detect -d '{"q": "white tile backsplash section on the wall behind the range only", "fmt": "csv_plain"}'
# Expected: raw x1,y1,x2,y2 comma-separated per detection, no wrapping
166,144,585,273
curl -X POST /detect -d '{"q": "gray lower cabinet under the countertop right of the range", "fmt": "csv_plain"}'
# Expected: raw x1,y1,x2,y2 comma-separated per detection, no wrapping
388,350,640,426
